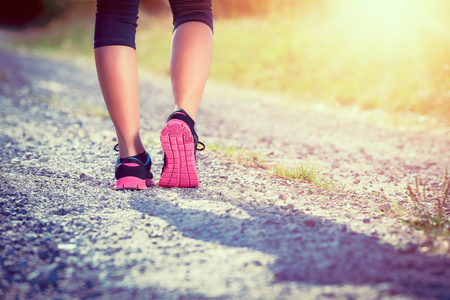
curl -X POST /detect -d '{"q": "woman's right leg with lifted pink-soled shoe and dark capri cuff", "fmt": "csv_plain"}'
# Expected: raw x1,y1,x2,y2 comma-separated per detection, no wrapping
159,0,213,187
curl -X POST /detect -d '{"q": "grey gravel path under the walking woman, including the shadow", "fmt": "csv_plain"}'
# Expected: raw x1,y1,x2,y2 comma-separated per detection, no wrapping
0,50,450,299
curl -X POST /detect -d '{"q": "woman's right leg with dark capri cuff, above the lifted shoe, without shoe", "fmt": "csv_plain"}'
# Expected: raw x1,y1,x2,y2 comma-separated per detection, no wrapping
169,0,213,120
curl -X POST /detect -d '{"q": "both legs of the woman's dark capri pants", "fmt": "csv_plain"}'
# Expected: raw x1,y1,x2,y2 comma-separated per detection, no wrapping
94,0,213,49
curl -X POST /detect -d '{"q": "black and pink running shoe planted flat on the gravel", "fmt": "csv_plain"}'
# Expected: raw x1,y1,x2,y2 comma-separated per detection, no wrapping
114,146,155,190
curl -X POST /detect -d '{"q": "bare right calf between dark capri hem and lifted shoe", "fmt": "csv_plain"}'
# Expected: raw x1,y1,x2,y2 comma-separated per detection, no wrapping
170,21,213,121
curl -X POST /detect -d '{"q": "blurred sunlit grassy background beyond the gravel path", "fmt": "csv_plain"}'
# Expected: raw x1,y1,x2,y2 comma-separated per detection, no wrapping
0,0,450,125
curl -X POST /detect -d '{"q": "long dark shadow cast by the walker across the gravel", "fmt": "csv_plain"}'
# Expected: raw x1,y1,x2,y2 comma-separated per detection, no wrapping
131,192,450,299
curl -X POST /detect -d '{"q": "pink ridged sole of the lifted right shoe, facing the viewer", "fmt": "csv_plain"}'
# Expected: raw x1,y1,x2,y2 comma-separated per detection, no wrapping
159,120,199,188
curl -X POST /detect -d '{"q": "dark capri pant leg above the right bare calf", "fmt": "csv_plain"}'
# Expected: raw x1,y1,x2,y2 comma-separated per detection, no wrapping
169,0,214,31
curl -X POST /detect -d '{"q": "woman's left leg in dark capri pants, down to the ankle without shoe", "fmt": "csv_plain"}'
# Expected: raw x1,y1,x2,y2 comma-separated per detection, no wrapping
94,0,145,158
